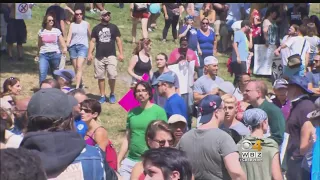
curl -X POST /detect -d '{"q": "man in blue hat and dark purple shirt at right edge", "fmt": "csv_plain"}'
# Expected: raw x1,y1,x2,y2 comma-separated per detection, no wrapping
286,75,315,179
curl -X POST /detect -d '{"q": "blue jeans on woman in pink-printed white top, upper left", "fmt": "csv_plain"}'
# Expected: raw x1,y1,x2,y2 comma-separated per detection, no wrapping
39,52,61,84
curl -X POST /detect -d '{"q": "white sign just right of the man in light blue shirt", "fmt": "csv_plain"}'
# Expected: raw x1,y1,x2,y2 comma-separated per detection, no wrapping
253,44,279,75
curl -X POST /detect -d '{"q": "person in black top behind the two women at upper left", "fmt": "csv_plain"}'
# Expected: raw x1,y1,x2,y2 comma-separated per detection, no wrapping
46,3,67,36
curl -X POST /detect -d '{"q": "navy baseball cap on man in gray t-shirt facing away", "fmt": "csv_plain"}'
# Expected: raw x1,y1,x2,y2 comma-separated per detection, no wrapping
199,95,222,124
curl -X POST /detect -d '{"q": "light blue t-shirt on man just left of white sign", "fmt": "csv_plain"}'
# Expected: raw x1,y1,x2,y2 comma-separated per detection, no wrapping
232,30,249,62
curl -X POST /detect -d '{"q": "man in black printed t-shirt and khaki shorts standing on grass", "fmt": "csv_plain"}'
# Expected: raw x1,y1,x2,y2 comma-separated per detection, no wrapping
88,10,123,104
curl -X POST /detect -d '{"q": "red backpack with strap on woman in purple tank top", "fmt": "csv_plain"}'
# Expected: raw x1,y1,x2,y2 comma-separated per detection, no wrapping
86,126,118,171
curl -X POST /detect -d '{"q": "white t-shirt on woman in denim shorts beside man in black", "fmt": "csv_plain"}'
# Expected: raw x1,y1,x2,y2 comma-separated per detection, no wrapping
70,21,89,47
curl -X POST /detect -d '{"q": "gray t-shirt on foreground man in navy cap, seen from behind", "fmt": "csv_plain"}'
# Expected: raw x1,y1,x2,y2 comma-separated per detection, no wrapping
176,128,238,180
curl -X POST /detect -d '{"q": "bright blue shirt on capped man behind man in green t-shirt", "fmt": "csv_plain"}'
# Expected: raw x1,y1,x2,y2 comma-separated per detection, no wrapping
163,93,188,119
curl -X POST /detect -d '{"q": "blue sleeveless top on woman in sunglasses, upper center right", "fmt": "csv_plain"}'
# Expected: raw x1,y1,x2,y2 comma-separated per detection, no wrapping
197,30,216,57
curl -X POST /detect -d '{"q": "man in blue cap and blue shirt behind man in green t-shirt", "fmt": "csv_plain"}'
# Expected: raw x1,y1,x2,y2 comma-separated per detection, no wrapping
152,73,191,124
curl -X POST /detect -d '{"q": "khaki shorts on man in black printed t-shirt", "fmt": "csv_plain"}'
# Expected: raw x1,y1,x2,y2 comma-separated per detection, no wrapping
94,56,118,79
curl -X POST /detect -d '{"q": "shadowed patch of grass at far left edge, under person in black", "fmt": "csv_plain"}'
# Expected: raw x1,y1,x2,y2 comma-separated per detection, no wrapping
0,46,39,74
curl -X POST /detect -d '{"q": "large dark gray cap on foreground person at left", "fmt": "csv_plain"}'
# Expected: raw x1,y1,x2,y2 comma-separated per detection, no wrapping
27,88,78,119
